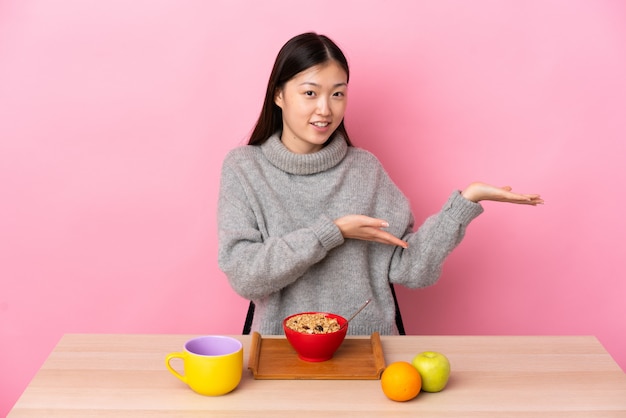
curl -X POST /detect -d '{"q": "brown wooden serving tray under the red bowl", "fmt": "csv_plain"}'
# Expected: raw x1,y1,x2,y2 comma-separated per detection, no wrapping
248,332,385,380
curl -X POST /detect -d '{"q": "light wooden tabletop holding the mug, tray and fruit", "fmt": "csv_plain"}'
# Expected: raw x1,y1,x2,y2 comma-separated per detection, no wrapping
9,334,626,418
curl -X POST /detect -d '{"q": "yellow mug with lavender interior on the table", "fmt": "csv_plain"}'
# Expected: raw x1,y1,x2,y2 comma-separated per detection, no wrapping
165,335,243,396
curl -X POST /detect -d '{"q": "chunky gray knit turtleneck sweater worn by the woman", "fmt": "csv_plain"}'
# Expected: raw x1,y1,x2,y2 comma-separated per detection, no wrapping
218,135,483,335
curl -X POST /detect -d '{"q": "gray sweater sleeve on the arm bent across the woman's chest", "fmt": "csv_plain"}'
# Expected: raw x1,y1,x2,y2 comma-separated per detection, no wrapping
218,159,344,299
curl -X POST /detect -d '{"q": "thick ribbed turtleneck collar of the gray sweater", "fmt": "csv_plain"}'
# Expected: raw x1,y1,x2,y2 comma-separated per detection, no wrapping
261,133,348,175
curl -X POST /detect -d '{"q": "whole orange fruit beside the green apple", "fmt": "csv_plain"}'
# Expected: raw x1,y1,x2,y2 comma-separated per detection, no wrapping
380,361,422,402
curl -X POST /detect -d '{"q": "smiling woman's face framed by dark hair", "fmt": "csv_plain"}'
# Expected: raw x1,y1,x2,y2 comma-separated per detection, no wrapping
274,61,348,154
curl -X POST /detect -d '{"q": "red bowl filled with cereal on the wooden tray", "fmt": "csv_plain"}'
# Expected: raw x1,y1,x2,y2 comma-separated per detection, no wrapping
283,312,348,361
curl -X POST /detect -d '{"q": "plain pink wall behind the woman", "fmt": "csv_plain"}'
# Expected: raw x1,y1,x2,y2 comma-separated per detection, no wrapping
0,0,626,416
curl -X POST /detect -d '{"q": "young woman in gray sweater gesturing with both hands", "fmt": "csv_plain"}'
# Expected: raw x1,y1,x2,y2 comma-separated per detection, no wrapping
218,33,543,335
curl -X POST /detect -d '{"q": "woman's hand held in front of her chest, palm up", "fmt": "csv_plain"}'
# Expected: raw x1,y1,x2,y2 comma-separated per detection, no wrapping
335,215,409,248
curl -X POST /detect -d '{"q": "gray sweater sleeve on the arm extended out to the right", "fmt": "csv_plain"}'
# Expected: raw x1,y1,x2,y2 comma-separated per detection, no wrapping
389,191,483,288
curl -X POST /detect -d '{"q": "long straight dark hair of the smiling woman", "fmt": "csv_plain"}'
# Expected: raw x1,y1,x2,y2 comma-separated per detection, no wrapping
248,32,352,146
